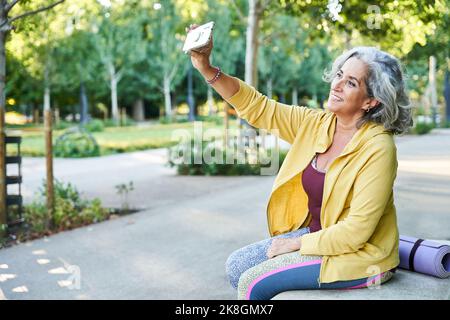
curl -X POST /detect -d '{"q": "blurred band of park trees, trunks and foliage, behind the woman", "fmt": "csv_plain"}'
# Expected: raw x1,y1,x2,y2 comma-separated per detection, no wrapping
5,0,450,135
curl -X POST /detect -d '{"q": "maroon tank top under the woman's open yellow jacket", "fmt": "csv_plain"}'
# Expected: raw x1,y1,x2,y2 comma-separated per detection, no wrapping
302,158,325,232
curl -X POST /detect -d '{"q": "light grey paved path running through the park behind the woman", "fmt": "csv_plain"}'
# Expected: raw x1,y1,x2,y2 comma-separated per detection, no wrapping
0,130,450,299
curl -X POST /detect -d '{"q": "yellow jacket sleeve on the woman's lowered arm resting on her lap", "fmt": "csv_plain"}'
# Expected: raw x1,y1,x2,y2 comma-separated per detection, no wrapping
300,144,398,256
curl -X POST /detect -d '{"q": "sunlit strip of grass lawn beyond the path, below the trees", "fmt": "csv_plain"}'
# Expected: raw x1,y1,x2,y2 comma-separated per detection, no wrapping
7,121,236,157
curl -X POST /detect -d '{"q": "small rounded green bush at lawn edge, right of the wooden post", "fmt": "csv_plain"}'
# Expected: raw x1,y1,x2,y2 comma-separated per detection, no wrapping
53,127,100,158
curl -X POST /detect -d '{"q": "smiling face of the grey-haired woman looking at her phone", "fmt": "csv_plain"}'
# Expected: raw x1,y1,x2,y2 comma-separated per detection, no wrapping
328,57,372,118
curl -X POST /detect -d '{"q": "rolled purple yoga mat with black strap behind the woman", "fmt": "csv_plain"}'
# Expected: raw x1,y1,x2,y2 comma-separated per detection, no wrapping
399,235,450,278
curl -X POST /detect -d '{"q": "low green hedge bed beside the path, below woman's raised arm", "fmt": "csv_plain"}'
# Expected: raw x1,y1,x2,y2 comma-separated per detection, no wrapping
167,140,287,176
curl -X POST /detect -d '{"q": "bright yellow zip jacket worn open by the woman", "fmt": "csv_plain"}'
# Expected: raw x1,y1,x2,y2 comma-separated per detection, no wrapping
227,78,400,283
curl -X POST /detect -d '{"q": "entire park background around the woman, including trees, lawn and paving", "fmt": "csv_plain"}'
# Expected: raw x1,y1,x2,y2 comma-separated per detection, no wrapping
0,0,450,300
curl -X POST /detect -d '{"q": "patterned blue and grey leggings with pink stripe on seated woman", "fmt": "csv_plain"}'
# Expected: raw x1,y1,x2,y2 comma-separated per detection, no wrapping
226,227,392,300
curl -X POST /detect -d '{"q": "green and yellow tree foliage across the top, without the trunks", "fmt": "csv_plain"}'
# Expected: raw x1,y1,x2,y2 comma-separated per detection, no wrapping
6,0,450,120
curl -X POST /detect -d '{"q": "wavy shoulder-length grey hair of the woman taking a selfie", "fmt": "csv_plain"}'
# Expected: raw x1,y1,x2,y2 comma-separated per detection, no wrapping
323,47,413,134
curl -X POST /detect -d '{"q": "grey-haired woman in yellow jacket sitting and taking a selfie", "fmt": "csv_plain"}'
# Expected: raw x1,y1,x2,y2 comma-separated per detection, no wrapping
185,25,412,299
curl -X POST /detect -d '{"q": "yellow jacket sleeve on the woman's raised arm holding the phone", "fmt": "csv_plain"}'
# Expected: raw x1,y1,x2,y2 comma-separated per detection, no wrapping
226,78,323,144
